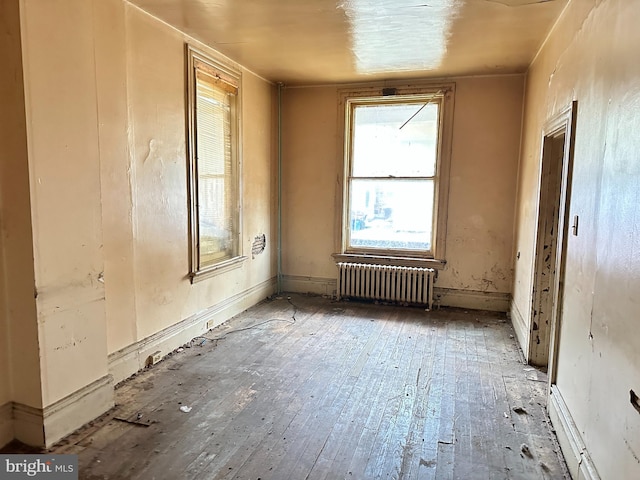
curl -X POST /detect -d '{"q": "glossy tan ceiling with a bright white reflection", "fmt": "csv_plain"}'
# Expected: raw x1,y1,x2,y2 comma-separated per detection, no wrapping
129,0,568,85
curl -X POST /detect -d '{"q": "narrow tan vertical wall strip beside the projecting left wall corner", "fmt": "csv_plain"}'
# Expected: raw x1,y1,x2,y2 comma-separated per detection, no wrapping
94,1,136,352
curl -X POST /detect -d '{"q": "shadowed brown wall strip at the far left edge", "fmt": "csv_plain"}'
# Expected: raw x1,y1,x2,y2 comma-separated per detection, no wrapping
0,1,42,416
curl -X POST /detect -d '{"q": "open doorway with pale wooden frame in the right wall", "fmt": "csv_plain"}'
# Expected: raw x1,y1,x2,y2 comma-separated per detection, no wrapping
529,102,577,372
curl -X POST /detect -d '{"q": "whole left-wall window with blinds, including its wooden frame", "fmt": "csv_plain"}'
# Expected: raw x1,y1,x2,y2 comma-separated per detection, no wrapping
187,46,244,281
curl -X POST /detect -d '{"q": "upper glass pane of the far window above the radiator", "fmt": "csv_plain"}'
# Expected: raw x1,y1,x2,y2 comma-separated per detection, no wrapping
351,103,438,177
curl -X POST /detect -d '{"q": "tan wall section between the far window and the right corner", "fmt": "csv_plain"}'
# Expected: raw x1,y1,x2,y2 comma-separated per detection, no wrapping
436,76,524,306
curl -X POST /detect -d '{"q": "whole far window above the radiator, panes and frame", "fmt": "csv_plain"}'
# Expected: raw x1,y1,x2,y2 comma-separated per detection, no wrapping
342,86,452,260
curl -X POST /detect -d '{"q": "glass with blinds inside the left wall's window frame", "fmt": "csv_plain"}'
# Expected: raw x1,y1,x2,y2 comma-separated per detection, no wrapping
196,79,235,267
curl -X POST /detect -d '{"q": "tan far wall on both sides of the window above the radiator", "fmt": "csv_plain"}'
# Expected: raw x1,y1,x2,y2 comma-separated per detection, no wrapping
283,75,523,310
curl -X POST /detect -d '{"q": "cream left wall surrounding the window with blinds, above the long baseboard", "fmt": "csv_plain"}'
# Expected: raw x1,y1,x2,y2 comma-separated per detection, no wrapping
100,4,275,353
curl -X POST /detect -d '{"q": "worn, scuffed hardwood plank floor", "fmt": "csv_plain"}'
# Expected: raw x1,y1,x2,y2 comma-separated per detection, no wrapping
53,295,569,480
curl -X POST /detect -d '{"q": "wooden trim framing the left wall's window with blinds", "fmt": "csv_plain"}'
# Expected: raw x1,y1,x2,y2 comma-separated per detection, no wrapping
185,44,247,283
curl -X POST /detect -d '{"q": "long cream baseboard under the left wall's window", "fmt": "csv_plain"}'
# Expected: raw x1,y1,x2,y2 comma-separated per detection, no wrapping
109,278,276,384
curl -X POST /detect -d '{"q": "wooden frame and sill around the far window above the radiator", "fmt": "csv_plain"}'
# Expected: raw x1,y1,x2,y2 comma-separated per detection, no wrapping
333,83,455,268
